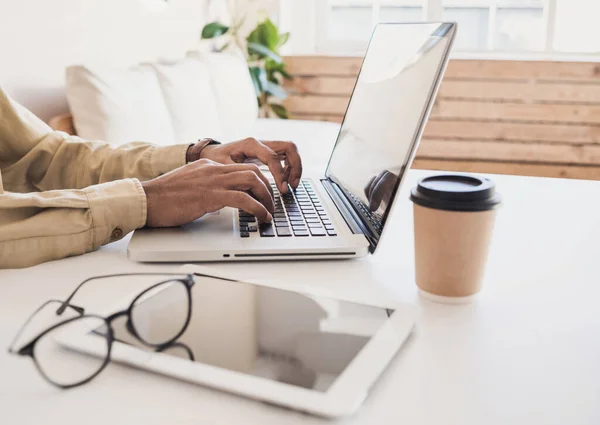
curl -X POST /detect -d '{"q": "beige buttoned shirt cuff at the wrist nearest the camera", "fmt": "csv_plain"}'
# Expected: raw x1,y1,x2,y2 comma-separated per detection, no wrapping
83,179,147,249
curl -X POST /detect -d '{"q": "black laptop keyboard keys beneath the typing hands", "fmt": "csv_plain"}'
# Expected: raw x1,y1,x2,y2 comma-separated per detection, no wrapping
239,180,337,238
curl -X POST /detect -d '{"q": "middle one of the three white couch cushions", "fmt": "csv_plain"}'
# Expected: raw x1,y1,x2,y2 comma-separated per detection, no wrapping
151,58,223,143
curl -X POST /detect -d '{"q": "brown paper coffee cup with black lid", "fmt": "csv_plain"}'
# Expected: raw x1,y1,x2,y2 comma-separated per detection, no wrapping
410,174,501,303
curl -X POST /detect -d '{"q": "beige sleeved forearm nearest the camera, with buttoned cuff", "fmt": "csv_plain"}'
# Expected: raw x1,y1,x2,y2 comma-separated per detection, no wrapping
0,179,146,268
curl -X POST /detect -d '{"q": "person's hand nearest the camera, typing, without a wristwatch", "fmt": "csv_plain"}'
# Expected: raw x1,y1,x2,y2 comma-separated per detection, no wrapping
142,159,275,227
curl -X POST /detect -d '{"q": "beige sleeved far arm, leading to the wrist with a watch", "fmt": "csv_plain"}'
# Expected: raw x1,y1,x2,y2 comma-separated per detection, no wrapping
0,88,189,193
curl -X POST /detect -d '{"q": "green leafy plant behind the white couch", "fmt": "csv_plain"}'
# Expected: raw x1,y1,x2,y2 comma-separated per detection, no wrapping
202,18,292,119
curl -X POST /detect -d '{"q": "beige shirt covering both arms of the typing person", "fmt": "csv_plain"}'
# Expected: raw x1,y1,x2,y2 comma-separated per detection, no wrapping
0,88,189,268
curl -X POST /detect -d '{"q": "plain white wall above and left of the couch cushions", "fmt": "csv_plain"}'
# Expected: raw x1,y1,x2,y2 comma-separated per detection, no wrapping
0,0,211,120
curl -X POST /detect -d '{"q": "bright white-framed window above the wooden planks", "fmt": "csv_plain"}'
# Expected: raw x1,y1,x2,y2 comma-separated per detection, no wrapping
290,0,600,59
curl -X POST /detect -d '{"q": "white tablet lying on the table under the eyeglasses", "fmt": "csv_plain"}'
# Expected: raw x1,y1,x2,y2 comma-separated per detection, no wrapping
60,267,415,417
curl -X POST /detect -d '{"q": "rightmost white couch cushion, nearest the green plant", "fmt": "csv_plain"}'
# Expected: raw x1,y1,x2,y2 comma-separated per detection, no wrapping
188,51,258,140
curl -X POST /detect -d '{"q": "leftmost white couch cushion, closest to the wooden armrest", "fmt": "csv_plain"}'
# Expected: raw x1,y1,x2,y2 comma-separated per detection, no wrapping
66,66,176,145
